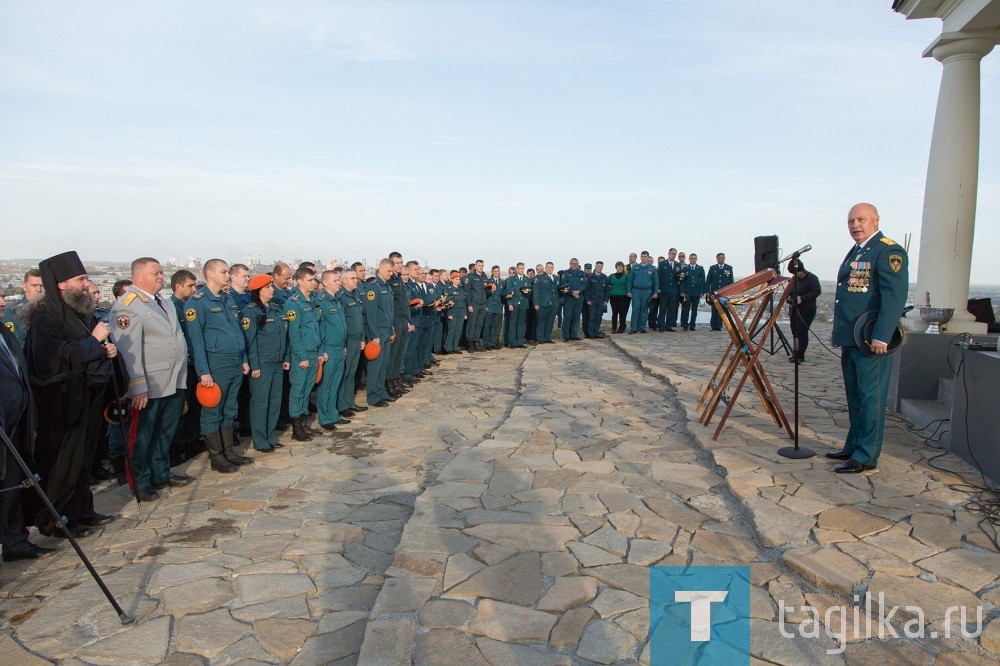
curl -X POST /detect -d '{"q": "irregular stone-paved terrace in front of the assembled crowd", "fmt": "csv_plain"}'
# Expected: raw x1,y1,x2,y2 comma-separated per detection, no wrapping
0,326,1000,666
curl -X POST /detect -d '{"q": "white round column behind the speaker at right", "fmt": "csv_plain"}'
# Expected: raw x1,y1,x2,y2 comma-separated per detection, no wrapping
907,37,995,333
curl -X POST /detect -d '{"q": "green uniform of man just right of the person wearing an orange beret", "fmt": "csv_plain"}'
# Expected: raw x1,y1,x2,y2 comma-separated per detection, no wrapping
285,288,320,421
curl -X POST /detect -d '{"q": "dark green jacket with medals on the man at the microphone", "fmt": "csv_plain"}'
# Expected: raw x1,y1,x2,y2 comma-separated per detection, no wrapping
833,231,910,347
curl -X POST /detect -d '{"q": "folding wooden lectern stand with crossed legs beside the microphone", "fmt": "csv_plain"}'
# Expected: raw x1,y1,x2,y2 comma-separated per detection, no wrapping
697,268,795,440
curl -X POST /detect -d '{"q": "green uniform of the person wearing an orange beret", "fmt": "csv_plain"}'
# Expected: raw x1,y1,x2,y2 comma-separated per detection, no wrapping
240,299,289,451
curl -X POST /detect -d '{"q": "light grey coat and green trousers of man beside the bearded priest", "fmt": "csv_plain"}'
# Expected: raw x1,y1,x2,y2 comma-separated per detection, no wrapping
110,285,188,491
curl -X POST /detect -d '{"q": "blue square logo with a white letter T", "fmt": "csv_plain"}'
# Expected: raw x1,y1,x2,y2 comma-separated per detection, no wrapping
649,567,750,666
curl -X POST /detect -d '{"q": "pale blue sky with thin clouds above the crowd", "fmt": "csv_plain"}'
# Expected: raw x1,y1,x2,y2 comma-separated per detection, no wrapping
0,0,1000,283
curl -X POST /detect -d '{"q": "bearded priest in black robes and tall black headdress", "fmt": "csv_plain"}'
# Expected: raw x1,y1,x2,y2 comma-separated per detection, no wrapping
26,251,118,537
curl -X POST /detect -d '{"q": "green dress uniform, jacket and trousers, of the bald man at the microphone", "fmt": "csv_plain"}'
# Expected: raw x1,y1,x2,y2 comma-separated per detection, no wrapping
833,231,910,467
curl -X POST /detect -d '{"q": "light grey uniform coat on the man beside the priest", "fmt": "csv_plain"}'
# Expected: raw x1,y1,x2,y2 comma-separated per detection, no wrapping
109,286,187,400
